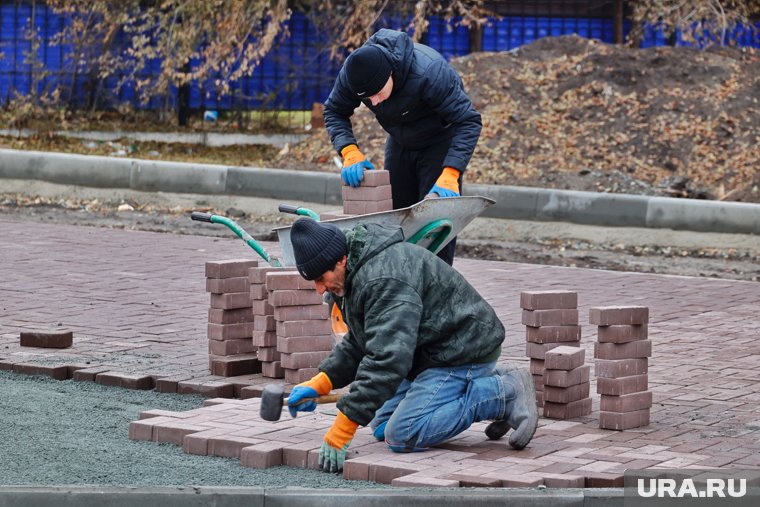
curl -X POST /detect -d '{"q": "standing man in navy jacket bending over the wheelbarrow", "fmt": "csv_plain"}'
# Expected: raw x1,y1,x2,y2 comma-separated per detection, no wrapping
324,29,482,265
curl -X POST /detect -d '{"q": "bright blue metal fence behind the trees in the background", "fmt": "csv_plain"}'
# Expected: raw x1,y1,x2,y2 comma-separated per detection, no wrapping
0,1,760,110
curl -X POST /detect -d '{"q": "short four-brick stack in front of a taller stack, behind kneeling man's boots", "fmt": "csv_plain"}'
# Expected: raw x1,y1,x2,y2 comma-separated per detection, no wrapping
544,346,591,419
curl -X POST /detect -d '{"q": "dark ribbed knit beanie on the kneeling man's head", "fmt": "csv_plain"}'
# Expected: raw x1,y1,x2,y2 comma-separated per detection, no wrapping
290,218,348,280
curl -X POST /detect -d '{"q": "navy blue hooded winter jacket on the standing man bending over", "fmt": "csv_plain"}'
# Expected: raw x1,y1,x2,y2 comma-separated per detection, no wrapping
325,29,482,172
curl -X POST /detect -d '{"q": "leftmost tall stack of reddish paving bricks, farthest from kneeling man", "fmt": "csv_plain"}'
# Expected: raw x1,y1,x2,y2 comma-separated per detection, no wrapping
206,259,260,377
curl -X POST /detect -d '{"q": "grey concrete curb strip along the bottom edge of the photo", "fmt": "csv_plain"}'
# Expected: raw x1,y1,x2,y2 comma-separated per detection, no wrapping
0,486,623,507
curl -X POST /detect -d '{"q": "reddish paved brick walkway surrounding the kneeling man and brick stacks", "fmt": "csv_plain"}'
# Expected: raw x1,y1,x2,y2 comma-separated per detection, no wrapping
0,217,760,487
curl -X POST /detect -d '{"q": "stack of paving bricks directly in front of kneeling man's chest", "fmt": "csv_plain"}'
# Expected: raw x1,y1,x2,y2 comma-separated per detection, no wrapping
267,272,332,384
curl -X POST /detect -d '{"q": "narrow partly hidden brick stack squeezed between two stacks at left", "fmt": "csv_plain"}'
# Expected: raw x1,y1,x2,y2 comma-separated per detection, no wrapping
247,266,290,378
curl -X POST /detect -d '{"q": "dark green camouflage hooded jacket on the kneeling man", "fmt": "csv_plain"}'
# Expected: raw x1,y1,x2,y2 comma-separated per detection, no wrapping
319,224,504,426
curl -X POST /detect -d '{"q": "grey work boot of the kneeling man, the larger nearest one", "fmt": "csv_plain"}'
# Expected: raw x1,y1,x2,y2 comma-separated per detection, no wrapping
486,368,538,450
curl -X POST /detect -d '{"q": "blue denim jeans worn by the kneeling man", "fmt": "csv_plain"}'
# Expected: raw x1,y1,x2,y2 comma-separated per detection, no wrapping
370,362,506,452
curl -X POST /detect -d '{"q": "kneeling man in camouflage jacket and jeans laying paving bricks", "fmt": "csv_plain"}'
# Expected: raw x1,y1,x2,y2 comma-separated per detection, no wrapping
288,218,538,472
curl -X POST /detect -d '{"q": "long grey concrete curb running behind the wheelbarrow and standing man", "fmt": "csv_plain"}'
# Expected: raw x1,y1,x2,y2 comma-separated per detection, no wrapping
0,150,760,234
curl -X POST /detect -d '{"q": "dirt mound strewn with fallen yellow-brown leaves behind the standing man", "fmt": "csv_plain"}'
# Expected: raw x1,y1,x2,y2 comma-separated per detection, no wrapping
274,36,760,202
